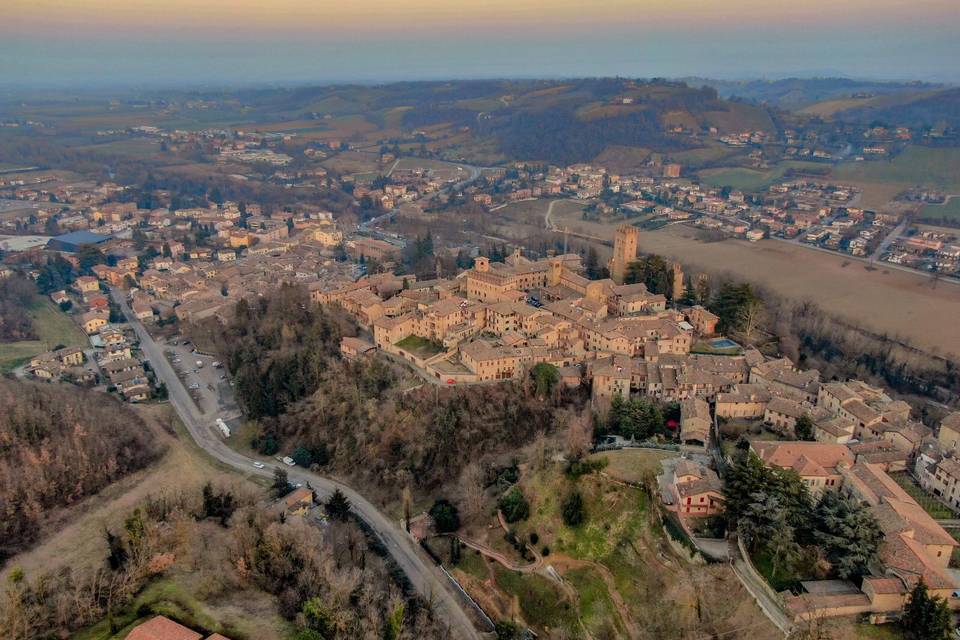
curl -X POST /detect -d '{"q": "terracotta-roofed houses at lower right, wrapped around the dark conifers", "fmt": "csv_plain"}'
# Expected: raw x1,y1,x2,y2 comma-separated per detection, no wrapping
664,352,960,621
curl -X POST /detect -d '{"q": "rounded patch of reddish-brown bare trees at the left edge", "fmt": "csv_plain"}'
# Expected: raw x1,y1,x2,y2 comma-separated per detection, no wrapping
0,380,161,562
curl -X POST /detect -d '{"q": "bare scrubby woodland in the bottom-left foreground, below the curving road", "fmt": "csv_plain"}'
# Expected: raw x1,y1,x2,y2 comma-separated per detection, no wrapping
0,484,449,640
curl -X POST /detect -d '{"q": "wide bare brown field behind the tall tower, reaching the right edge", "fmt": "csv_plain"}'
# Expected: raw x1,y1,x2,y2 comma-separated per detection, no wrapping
553,210,960,356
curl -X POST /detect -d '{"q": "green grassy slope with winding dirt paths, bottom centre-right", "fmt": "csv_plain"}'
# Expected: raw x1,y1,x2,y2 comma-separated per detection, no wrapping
476,451,775,639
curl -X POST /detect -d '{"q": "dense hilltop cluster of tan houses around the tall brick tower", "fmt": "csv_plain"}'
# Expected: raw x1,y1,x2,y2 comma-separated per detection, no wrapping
312,227,723,400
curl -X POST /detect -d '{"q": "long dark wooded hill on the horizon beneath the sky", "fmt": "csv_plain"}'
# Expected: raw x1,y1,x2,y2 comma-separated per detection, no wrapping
199,78,775,164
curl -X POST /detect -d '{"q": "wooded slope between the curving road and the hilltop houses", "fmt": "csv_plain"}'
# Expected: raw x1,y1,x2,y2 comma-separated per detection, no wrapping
202,287,584,489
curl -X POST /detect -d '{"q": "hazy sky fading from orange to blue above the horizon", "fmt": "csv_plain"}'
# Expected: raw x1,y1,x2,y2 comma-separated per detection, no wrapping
0,0,960,88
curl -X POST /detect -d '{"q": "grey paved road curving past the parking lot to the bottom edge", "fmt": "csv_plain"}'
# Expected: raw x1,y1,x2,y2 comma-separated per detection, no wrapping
110,289,481,640
